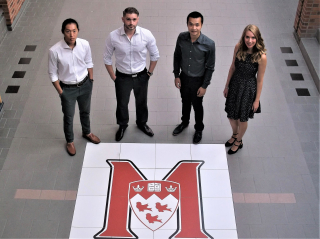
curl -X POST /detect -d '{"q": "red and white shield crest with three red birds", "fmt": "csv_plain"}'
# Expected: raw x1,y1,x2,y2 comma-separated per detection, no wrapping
129,180,180,231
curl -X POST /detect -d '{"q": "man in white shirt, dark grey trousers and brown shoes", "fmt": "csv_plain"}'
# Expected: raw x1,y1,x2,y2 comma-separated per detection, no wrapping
49,18,100,156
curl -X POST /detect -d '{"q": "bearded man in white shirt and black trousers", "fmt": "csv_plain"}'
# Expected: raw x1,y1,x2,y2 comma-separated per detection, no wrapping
103,7,159,141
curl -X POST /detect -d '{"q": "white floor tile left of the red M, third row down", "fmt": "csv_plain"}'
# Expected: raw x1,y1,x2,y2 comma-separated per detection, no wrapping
72,196,107,230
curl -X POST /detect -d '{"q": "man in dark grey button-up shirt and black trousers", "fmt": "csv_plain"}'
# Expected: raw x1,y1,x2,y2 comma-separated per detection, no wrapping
173,12,215,144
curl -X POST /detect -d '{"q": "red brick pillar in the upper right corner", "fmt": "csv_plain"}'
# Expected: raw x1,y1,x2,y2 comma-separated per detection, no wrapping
294,0,320,38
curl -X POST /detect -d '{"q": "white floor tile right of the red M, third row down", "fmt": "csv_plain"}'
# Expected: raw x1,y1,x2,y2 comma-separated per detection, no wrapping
202,198,237,230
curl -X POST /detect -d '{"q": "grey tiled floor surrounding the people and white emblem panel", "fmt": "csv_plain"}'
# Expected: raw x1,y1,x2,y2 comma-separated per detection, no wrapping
0,0,319,238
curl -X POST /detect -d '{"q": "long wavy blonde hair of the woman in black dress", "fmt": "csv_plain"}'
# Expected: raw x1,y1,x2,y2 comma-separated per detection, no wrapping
236,24,267,63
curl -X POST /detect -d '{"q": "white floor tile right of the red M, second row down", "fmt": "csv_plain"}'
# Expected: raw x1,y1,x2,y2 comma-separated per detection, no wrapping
200,170,232,198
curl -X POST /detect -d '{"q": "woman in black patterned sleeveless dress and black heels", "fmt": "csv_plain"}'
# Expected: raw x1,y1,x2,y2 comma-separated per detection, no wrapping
223,24,267,154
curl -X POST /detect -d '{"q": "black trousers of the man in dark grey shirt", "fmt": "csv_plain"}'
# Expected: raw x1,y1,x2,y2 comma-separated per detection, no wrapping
180,72,204,131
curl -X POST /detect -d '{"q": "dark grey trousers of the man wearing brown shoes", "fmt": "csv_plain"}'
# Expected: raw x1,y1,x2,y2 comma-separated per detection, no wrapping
60,79,93,143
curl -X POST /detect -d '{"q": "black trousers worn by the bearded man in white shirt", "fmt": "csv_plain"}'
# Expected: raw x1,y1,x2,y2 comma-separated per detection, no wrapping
115,72,150,126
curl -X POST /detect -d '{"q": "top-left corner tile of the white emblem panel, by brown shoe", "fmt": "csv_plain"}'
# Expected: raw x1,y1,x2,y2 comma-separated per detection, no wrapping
82,143,120,168
